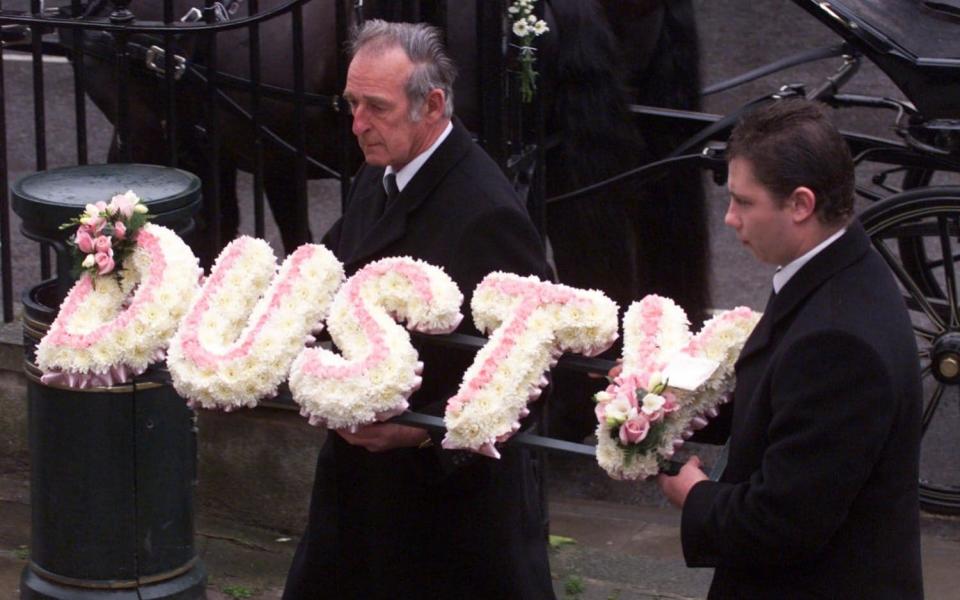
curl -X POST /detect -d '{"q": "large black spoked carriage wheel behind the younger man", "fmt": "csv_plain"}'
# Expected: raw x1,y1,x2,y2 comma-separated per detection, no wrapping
860,186,960,514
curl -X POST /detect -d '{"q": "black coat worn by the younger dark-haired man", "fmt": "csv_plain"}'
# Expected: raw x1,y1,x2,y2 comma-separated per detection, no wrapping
682,223,923,600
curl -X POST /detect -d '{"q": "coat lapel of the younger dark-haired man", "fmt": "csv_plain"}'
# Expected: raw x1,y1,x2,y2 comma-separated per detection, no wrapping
737,221,870,367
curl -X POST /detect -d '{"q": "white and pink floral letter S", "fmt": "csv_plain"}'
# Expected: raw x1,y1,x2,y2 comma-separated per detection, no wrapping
290,257,463,429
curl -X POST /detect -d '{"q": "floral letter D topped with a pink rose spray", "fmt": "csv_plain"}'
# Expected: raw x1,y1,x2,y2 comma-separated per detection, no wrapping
37,192,202,388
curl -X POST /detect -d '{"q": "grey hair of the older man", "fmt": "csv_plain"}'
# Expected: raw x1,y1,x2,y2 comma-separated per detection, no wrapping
348,19,457,121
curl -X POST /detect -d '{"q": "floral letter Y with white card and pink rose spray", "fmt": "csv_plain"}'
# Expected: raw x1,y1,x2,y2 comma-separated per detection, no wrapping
594,295,760,479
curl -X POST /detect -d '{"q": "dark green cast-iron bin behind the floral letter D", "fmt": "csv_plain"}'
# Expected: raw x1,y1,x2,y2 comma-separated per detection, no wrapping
12,164,206,600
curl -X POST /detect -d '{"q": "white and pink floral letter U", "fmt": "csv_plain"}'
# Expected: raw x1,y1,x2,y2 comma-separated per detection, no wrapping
167,236,344,411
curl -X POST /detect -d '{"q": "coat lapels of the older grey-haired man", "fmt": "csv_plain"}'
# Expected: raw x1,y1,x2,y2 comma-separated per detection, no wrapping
344,118,473,268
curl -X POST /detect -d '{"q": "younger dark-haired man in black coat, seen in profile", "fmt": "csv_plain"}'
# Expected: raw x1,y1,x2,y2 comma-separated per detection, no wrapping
660,100,923,600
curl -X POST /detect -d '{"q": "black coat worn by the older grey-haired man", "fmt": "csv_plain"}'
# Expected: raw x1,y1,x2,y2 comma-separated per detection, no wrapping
284,124,553,600
